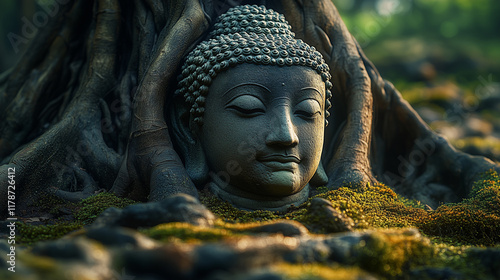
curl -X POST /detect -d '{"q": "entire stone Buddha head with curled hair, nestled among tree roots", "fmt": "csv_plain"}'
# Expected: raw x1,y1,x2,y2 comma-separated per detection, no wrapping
172,6,332,210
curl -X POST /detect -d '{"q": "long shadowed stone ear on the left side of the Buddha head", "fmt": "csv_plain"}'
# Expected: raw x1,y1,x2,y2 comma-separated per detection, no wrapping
169,96,209,186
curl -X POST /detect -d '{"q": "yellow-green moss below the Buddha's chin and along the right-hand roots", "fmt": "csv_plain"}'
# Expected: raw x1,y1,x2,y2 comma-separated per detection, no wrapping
201,171,500,246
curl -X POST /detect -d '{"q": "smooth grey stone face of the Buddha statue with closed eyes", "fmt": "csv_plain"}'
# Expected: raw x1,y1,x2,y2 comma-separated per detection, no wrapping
196,64,326,198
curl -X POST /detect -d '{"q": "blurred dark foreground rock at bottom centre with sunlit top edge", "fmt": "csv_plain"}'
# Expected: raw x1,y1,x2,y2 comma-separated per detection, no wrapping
120,235,298,279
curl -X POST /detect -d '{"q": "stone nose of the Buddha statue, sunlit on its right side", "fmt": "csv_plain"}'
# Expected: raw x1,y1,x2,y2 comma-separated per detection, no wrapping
266,107,299,146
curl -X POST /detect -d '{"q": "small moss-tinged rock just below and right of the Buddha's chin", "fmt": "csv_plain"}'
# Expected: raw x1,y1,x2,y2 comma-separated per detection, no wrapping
306,197,354,233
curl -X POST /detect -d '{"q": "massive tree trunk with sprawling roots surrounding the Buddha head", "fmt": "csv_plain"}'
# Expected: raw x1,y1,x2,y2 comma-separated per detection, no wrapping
0,0,499,219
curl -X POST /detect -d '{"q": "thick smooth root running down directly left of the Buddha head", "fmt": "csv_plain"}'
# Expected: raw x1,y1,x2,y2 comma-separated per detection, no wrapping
112,0,208,201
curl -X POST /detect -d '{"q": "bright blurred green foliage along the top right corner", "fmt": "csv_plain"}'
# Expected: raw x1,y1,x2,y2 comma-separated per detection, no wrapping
333,0,500,40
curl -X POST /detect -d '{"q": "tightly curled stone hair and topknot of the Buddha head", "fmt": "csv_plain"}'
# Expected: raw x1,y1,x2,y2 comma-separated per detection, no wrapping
176,5,332,125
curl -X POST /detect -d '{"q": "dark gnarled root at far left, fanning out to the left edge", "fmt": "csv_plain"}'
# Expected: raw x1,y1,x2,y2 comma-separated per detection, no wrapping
0,0,120,216
